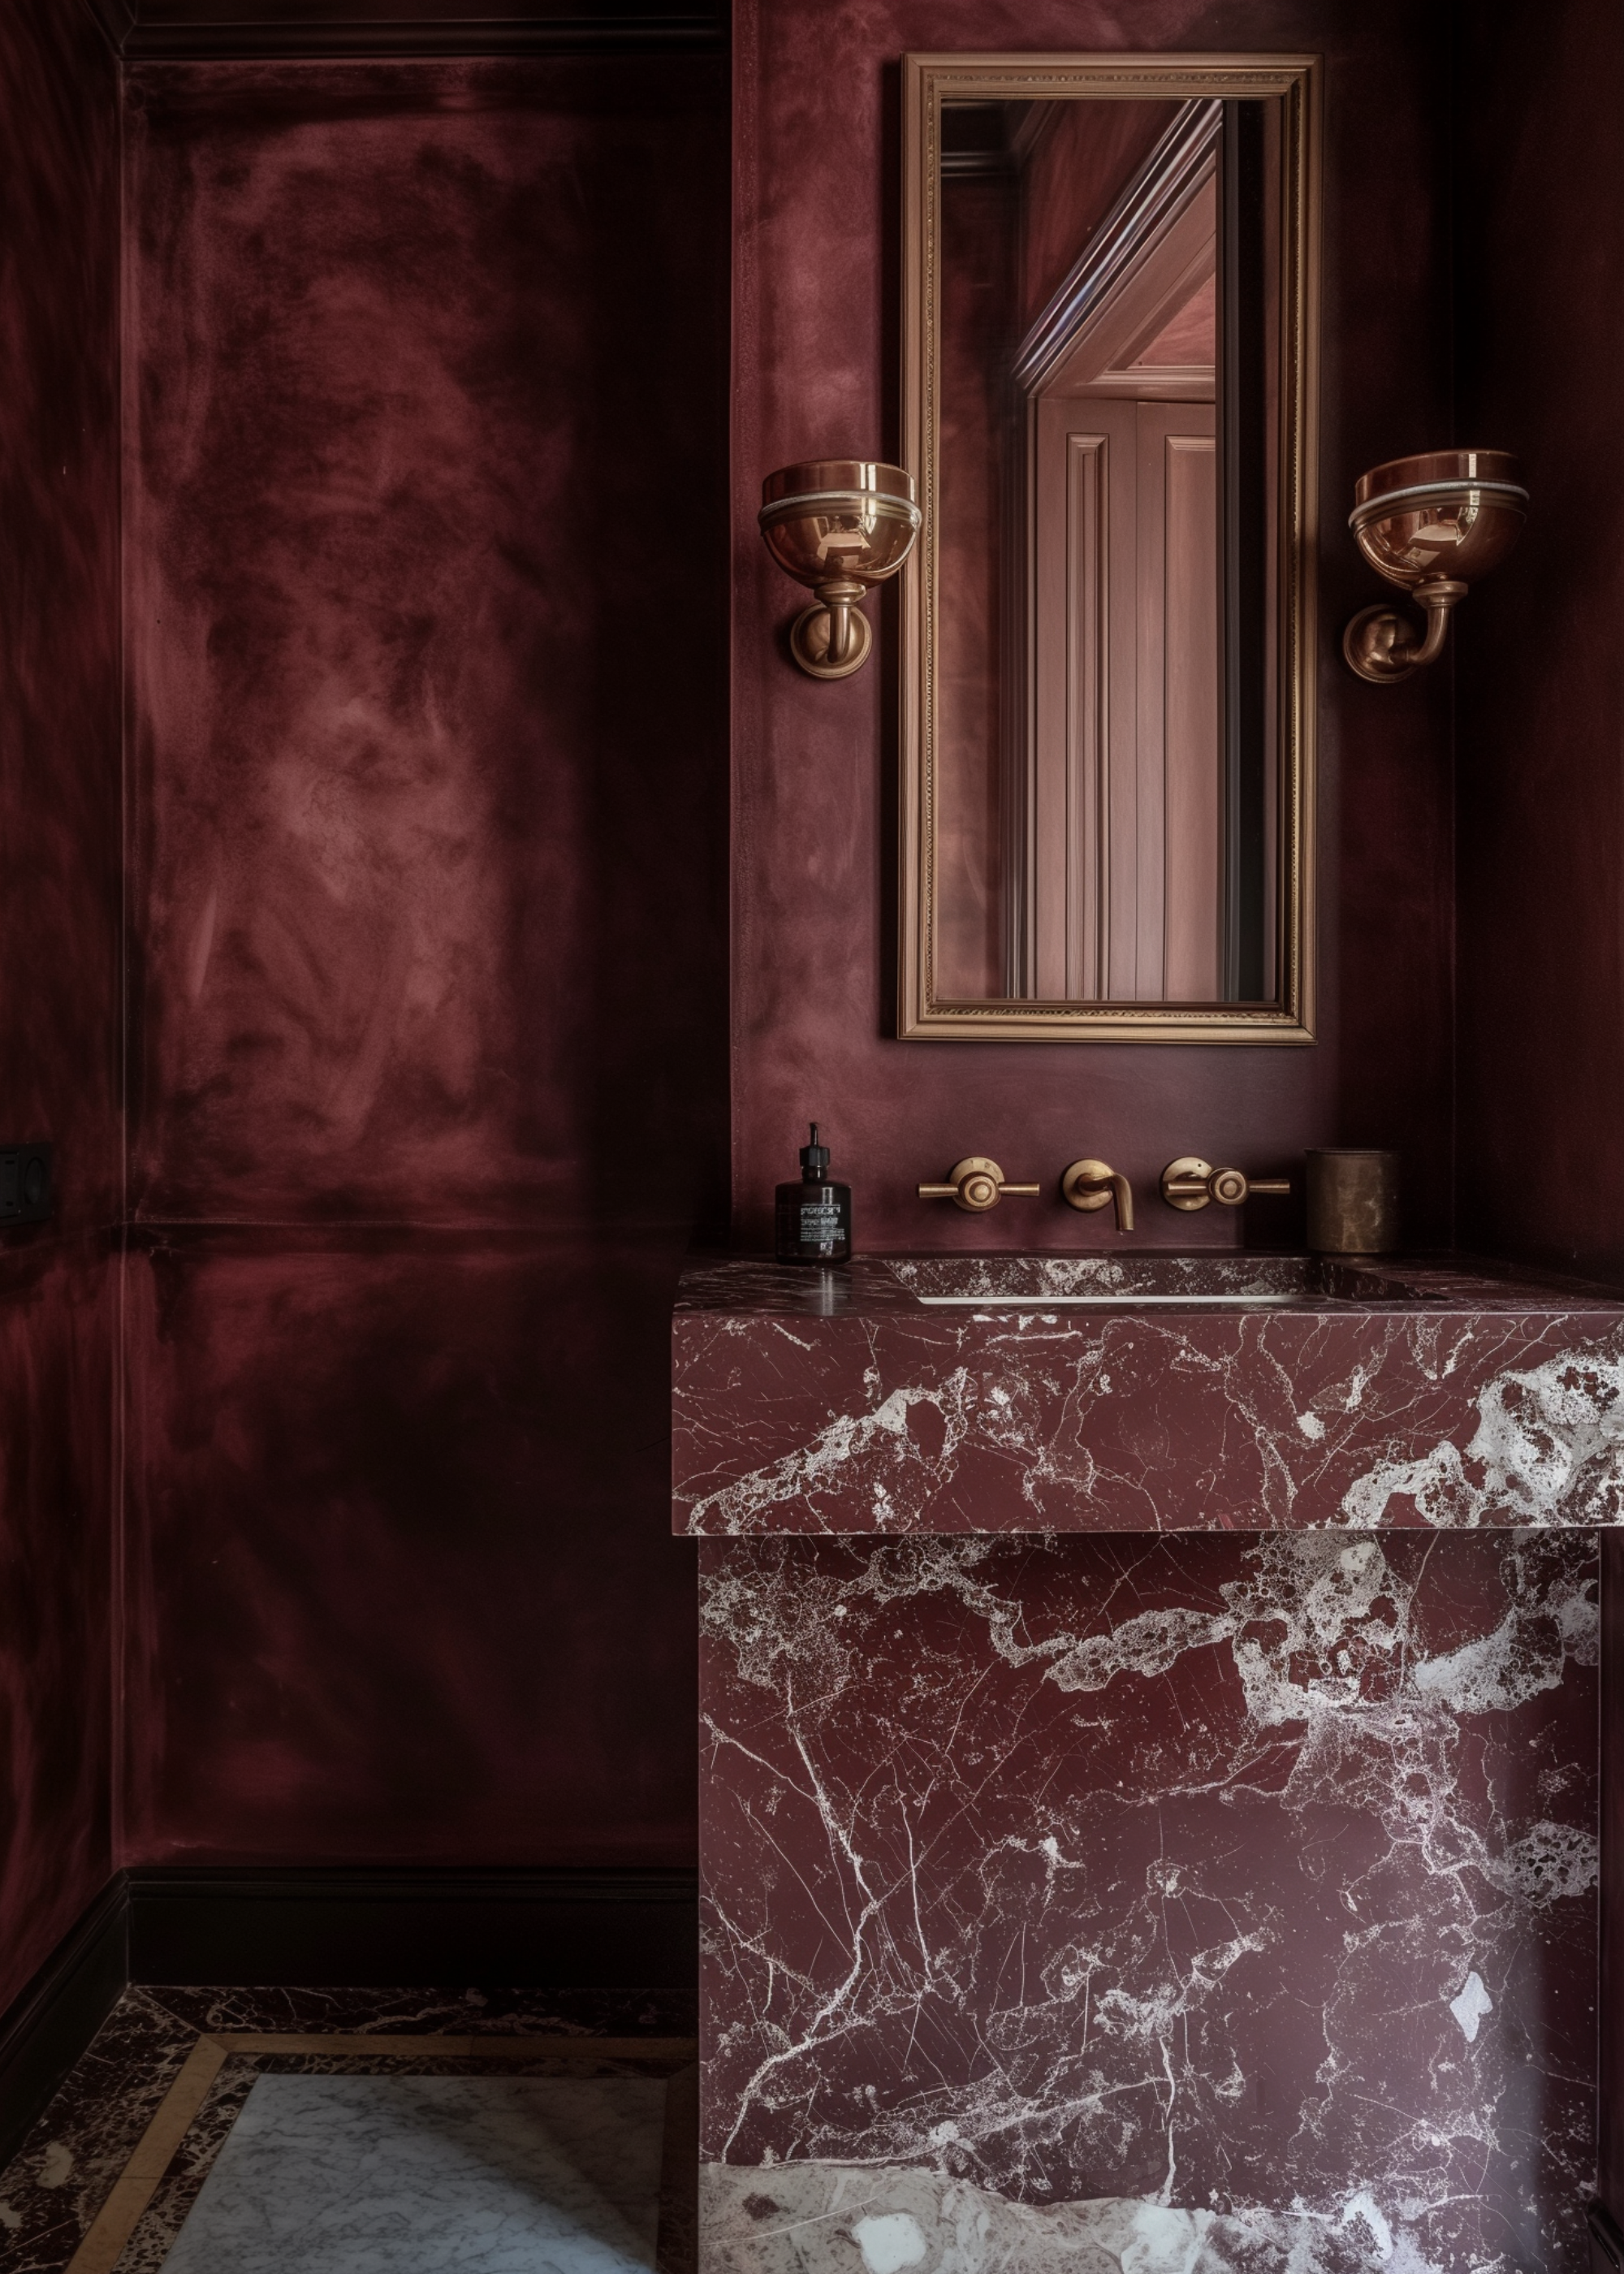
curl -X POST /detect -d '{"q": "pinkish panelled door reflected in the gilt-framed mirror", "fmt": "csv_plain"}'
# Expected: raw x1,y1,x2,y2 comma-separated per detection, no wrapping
1032,396,1224,1003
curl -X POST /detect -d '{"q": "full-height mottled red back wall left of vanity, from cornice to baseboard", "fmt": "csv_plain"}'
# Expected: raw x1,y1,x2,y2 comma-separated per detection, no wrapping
127,59,728,1862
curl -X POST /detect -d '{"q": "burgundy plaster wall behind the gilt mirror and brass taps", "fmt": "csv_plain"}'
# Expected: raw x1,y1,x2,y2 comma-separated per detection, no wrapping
732,0,1453,1248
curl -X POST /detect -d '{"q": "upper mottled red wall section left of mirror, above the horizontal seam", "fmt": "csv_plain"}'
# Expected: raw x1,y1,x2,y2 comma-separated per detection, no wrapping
130,62,726,1223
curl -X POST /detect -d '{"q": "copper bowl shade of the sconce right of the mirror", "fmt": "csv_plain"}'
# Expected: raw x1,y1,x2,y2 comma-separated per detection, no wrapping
1349,450,1528,591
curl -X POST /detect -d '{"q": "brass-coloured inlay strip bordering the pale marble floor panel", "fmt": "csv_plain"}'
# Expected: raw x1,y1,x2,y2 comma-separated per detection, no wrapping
63,2029,698,2274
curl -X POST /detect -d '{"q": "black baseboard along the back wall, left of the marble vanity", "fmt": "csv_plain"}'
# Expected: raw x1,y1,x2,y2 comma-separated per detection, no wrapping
127,1867,698,1990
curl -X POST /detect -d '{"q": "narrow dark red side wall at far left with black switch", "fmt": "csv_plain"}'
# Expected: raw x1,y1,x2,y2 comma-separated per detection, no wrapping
0,0,120,2006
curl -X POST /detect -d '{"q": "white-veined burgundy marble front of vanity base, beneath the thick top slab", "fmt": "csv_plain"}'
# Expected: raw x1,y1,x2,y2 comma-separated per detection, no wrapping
705,1530,1596,2274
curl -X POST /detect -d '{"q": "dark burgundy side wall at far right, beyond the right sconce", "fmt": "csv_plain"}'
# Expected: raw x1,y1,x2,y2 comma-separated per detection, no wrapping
1456,0,1624,1278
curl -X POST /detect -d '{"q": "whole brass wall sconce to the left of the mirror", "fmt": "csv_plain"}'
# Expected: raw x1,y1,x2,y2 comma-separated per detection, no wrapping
755,457,923,680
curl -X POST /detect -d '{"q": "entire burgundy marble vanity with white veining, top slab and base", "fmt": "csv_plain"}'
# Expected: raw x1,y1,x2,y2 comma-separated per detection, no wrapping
673,1256,1624,2274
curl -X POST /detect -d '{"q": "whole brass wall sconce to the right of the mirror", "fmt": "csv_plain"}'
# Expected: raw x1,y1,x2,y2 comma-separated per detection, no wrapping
1342,450,1528,687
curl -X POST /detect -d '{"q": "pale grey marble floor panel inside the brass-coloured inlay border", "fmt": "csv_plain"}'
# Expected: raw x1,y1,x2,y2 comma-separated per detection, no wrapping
166,2076,667,2274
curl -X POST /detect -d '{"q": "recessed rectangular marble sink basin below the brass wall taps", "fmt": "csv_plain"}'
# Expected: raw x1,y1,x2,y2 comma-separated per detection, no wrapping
885,1256,1415,1310
